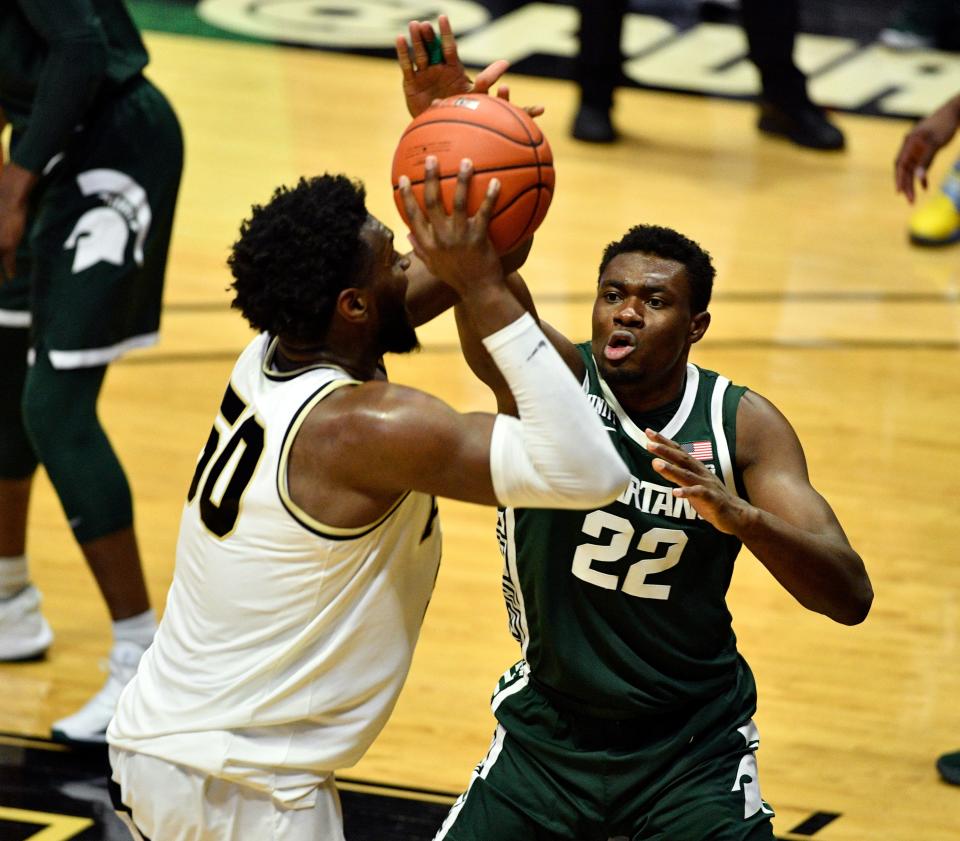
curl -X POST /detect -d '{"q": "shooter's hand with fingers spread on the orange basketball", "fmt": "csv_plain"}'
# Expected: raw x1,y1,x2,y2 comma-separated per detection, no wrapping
399,155,503,297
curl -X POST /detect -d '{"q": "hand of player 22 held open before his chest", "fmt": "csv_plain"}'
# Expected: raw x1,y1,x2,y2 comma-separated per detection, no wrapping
644,429,753,534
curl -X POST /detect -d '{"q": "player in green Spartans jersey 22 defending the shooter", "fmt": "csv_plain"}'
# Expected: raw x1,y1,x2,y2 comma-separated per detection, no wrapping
398,16,873,841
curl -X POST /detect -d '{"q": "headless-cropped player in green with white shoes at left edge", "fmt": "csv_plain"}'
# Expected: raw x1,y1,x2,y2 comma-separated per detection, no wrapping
0,0,183,742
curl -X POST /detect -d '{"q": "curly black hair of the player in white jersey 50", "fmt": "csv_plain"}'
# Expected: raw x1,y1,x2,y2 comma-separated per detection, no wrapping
227,174,369,342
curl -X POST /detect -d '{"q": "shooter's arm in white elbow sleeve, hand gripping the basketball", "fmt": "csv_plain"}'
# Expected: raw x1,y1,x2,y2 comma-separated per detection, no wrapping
293,158,629,525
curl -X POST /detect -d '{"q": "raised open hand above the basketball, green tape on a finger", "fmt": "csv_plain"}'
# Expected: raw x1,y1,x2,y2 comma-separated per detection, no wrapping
396,15,510,117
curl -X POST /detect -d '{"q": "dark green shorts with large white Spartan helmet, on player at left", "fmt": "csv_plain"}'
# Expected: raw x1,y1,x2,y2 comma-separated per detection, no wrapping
0,76,183,368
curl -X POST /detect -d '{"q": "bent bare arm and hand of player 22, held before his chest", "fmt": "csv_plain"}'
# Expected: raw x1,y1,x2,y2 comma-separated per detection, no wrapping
646,392,873,625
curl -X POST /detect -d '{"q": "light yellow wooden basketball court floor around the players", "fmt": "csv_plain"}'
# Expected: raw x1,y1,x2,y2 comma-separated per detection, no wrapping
0,29,960,841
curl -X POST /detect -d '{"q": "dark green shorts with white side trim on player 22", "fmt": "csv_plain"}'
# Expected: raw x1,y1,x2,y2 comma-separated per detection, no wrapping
434,661,773,841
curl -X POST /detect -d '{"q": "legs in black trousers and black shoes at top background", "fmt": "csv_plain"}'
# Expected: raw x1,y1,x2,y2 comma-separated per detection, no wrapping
572,0,844,150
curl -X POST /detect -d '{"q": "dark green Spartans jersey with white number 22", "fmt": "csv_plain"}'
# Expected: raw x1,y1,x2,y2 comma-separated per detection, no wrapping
498,342,754,718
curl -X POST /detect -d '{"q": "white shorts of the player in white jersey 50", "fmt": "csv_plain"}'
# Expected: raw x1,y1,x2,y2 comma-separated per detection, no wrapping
110,747,344,841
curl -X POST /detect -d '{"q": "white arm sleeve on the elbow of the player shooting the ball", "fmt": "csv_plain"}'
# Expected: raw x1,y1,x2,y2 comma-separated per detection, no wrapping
483,313,630,508
